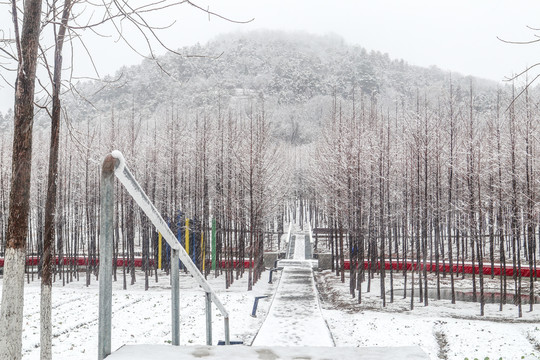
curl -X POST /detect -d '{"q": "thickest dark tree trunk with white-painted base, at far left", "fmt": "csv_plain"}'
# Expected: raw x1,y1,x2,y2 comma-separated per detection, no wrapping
0,0,42,360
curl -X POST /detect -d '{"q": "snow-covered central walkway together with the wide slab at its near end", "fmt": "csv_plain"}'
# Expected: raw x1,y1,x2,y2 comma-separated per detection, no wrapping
107,224,429,360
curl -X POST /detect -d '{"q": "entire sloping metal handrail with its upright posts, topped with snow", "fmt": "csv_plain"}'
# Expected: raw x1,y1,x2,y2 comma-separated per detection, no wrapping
98,151,230,360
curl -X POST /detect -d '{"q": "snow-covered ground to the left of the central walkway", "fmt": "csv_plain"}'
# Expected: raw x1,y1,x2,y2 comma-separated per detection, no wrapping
0,272,279,360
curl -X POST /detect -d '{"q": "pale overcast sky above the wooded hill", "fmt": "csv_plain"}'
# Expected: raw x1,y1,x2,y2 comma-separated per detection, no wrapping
0,0,540,112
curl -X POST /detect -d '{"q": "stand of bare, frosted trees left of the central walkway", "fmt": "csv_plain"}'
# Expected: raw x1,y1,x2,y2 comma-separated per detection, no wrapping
0,99,289,289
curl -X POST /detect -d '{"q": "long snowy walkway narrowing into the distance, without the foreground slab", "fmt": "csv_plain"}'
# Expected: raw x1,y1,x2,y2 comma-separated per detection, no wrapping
252,228,334,346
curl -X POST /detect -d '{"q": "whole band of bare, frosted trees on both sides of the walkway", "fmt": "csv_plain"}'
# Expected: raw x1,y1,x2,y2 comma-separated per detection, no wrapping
0,28,540,340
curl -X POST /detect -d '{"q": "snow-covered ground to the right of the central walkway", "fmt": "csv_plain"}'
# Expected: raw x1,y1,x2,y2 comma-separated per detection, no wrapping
317,271,540,360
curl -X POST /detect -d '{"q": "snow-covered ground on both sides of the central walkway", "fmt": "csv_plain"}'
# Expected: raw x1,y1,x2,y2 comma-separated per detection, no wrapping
0,271,540,360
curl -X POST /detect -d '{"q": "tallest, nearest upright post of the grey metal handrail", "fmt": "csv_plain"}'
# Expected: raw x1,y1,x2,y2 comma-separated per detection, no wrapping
98,155,116,360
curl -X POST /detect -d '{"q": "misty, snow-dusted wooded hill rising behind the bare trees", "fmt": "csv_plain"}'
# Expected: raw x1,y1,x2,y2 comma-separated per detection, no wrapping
57,31,496,141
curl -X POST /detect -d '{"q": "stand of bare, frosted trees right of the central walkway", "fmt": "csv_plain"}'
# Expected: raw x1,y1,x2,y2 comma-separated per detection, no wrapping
304,80,540,316
